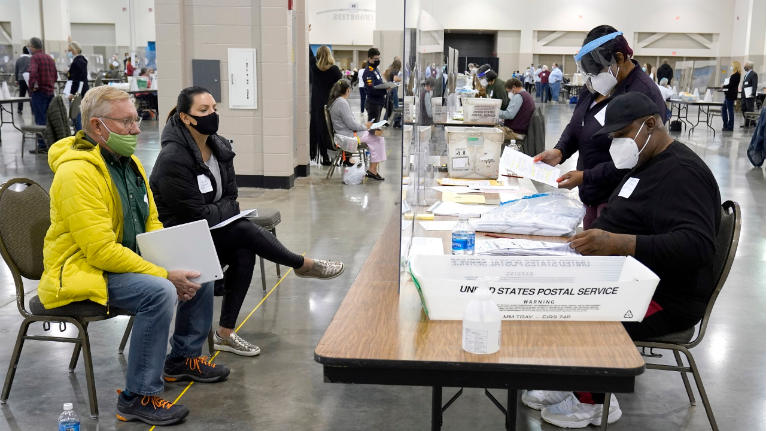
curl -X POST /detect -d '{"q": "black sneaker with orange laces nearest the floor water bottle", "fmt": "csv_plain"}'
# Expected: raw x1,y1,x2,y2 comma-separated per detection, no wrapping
116,391,189,425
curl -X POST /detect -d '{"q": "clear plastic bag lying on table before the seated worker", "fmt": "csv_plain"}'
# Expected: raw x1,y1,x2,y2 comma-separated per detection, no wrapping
472,193,586,236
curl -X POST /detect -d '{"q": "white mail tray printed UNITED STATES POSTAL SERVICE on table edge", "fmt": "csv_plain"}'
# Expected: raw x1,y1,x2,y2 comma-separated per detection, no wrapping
410,255,660,322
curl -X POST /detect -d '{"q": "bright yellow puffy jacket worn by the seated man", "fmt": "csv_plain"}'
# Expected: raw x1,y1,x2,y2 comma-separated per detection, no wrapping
37,131,168,308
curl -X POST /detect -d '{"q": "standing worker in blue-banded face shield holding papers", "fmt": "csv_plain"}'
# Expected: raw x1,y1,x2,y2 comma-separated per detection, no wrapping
535,25,666,229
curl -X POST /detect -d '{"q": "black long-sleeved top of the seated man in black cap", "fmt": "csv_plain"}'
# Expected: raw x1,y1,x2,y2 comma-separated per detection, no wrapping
593,141,722,324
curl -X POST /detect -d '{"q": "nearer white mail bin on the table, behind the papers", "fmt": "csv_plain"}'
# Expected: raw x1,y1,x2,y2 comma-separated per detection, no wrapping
445,127,503,180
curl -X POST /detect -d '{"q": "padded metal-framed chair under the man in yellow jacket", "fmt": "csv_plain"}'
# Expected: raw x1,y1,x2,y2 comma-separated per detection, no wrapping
0,178,127,419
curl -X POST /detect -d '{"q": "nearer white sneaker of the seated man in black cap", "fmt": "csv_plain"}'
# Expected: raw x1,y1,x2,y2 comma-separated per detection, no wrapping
541,394,623,428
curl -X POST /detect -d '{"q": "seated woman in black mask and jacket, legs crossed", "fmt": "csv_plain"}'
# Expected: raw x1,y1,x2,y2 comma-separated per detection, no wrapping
149,87,344,356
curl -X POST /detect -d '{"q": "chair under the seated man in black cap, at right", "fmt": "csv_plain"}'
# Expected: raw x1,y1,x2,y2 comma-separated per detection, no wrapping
634,201,741,431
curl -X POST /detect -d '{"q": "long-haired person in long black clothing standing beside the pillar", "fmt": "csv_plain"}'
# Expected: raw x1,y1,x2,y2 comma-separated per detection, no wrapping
309,45,343,166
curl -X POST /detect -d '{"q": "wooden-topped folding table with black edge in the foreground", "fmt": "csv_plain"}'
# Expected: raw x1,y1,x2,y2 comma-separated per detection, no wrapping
314,210,645,430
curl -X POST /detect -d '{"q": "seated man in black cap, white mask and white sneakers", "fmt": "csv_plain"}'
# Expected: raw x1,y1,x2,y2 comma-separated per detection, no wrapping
522,92,721,428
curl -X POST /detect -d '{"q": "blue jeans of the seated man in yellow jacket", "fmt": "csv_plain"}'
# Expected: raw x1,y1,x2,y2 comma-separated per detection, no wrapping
106,273,213,395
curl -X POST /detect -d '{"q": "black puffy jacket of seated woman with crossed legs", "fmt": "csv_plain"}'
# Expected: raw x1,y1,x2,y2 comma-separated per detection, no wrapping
149,114,240,227
